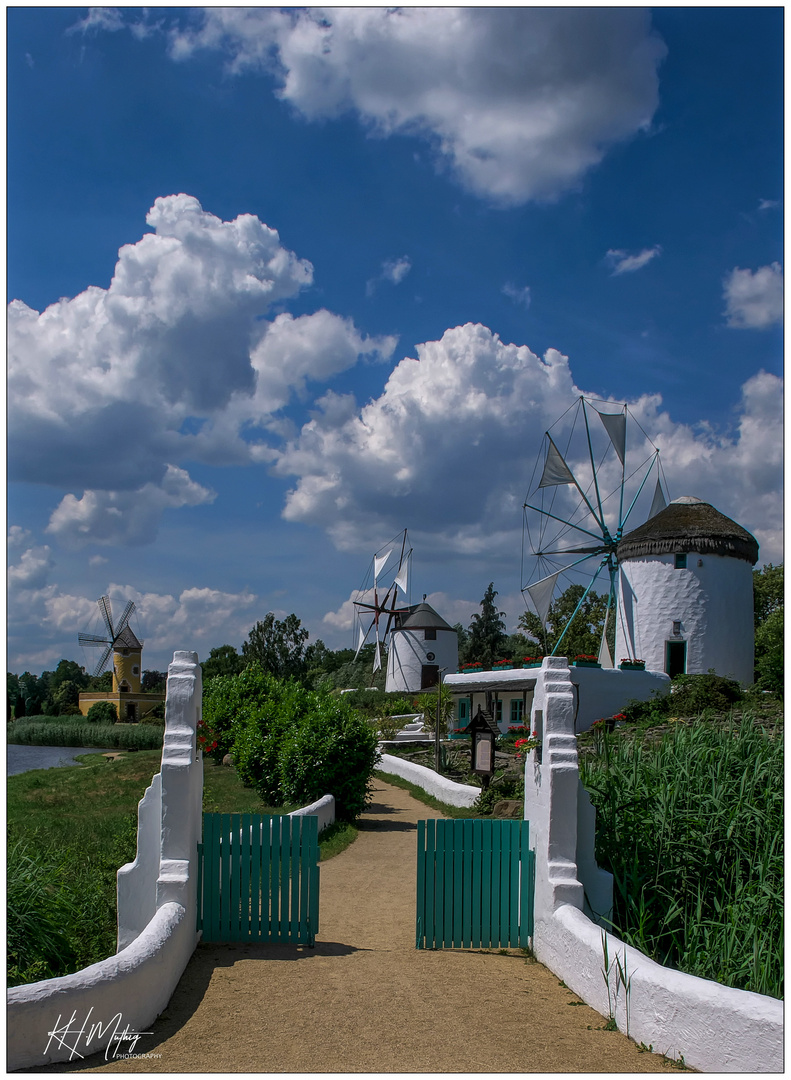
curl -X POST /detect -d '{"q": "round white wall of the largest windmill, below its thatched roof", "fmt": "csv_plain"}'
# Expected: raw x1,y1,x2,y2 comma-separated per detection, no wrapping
615,552,754,685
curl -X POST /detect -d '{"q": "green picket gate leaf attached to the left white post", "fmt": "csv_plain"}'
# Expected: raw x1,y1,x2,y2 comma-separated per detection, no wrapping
198,813,319,945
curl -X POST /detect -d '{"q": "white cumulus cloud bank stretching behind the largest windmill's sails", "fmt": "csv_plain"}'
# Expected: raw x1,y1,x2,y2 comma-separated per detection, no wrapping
276,324,782,559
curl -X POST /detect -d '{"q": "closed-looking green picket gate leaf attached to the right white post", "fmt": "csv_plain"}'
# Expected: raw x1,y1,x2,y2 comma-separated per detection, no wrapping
415,819,536,948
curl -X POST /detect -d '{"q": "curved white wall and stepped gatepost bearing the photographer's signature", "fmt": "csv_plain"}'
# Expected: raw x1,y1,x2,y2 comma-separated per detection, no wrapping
8,651,203,1070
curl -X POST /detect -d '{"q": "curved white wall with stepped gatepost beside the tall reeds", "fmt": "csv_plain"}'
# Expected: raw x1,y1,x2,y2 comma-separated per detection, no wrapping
525,658,783,1074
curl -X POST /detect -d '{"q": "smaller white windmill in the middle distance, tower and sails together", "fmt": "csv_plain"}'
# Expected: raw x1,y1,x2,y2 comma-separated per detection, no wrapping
353,529,458,693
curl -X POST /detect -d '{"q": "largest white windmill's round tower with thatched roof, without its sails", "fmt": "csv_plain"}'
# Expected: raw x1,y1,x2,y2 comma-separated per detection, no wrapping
614,496,759,685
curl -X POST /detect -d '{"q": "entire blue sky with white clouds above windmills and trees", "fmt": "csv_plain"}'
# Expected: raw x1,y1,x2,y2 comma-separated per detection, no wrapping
8,8,783,672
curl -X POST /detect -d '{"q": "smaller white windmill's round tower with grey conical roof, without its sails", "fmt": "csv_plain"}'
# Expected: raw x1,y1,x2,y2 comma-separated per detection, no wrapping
385,596,458,693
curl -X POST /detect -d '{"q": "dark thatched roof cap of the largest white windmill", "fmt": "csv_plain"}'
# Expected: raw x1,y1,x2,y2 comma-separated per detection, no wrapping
618,496,759,565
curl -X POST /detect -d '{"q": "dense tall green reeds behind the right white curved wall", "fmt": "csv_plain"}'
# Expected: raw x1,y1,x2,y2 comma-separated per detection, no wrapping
581,715,783,998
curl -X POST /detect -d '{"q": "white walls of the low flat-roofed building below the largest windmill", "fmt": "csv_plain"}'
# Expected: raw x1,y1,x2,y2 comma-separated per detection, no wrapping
444,657,670,733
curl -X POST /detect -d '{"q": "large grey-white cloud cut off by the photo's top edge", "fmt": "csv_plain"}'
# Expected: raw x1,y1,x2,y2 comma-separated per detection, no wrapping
171,6,666,204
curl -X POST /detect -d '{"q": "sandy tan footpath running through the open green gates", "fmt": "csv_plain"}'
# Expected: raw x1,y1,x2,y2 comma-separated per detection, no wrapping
55,781,675,1072
